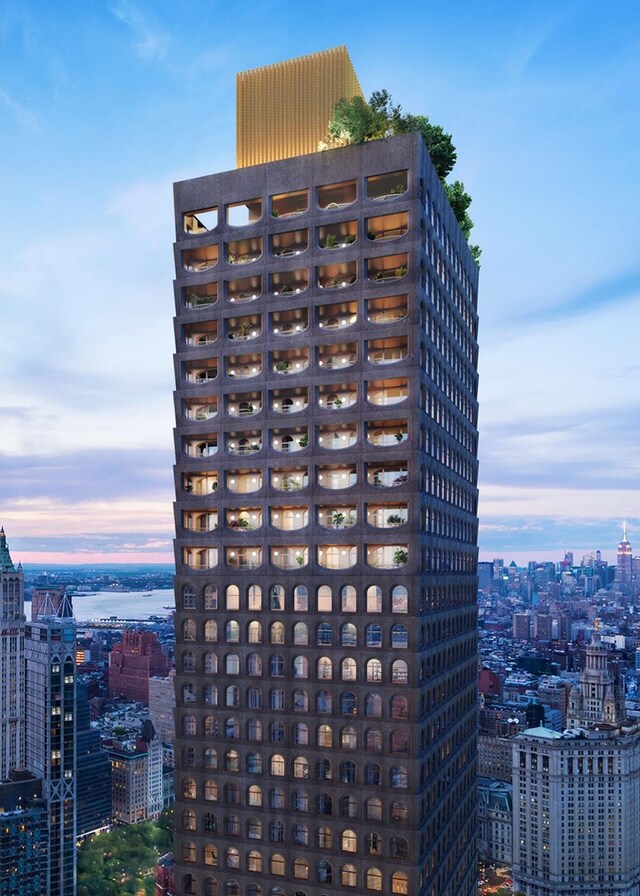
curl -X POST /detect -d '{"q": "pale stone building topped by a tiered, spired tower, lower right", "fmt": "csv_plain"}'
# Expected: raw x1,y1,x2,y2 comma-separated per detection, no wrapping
513,630,640,896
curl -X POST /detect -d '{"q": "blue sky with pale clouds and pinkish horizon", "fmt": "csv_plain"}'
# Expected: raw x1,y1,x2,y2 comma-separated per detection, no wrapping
0,0,640,563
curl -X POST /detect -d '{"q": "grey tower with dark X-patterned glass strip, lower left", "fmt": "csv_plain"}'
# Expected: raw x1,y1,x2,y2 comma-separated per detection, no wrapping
25,597,76,896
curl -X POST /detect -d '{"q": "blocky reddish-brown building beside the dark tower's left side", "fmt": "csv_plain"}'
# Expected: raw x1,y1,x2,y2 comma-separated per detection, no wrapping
109,631,169,706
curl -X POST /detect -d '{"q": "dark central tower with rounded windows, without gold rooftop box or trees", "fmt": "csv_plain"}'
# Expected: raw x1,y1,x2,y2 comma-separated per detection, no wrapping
175,49,478,896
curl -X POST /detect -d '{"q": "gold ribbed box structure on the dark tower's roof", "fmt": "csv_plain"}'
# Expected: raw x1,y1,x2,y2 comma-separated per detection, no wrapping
236,46,363,168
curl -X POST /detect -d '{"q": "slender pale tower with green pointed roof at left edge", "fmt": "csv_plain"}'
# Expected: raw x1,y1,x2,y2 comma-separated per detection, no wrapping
0,528,25,781
